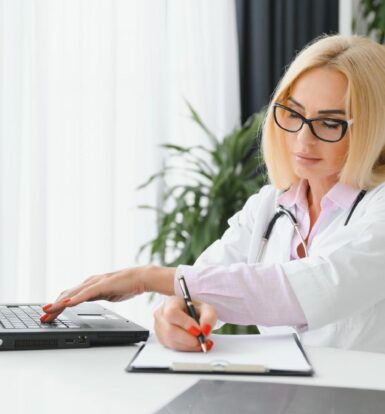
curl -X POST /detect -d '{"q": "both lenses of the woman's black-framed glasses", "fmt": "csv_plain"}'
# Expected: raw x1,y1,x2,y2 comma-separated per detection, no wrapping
274,107,345,141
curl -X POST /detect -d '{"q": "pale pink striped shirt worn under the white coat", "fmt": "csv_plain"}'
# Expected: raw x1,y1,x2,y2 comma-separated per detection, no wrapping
174,180,359,326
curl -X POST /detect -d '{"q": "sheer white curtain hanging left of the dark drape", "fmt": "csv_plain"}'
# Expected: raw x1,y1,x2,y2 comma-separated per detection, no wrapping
0,0,240,326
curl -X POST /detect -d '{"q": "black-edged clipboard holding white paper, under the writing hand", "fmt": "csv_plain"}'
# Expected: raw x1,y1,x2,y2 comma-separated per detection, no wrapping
126,333,314,376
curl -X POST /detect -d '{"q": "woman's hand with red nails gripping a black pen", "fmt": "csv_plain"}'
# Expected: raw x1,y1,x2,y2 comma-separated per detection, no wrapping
154,296,217,352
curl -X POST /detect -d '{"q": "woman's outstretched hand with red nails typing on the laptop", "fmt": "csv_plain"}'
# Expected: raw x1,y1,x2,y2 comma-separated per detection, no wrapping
40,266,148,323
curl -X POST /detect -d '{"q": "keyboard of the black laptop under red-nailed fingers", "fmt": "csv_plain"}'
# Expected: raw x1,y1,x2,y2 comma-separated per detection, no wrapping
0,305,80,329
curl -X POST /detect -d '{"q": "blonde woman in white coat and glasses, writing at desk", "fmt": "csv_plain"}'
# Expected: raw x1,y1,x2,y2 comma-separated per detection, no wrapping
42,36,385,352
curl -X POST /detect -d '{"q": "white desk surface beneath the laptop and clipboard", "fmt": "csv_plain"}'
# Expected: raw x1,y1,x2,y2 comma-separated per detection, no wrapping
0,340,385,414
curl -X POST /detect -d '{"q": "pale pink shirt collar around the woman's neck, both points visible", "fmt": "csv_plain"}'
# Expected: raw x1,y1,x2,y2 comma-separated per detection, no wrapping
278,179,360,210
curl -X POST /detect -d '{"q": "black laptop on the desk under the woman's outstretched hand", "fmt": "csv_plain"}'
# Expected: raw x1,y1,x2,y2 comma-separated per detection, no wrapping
0,302,149,351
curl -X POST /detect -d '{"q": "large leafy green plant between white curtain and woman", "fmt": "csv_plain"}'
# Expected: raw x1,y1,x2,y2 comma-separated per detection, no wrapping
138,104,266,333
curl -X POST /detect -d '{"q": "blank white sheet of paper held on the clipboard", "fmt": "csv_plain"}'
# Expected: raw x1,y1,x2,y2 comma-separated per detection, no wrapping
131,334,311,371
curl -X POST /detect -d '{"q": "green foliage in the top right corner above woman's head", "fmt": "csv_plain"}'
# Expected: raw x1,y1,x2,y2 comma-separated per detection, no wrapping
353,0,385,43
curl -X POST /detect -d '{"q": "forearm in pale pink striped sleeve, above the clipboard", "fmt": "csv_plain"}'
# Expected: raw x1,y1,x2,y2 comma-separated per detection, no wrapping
175,263,307,326
